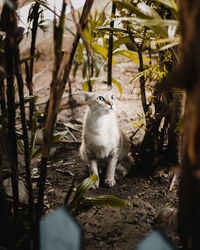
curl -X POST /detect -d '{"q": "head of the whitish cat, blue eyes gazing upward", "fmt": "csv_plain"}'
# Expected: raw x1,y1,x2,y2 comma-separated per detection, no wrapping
83,90,115,114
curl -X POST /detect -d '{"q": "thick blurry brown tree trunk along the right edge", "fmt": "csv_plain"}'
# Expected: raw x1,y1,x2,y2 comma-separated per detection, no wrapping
177,0,200,250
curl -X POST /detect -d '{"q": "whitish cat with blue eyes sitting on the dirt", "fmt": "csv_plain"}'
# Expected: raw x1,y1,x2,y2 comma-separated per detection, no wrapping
80,88,130,188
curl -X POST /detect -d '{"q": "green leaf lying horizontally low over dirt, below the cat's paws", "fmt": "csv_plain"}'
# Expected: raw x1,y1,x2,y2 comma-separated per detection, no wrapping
80,195,132,208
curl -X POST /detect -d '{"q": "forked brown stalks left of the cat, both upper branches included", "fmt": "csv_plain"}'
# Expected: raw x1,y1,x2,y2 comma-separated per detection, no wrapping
37,0,93,220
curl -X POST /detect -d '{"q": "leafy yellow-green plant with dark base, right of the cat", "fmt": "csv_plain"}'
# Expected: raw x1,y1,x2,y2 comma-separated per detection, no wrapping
111,0,180,173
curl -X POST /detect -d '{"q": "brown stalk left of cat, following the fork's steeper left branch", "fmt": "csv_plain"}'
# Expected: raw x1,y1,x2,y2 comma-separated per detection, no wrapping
36,0,66,221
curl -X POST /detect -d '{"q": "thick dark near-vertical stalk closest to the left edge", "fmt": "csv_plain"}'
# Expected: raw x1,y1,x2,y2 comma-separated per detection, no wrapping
4,1,19,216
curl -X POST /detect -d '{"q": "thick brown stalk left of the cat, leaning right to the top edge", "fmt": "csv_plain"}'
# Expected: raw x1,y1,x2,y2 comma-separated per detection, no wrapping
37,0,94,220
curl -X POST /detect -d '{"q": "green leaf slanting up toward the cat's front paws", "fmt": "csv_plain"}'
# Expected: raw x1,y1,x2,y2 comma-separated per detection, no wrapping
69,175,98,209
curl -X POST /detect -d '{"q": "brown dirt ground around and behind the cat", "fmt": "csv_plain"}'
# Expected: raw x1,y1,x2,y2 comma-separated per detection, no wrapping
21,39,178,250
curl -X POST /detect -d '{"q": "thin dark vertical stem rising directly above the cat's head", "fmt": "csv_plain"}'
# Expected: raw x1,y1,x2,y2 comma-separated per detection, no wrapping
107,2,116,86
